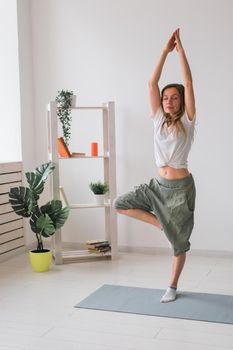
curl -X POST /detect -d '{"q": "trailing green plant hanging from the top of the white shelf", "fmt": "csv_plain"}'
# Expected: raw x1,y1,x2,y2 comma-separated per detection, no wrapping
56,90,74,146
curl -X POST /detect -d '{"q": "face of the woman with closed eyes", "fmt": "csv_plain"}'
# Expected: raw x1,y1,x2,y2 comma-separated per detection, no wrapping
162,87,180,115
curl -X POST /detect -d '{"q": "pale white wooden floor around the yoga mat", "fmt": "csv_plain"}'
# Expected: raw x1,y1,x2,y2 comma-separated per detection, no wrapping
0,253,233,350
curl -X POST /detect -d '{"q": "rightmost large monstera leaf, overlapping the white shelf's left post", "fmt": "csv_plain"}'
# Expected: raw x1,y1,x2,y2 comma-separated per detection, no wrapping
40,200,69,230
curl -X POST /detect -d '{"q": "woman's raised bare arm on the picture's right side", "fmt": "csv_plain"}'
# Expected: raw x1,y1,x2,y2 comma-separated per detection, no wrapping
175,29,195,120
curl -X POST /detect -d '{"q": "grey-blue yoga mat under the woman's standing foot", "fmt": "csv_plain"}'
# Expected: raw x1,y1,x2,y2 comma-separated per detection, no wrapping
75,284,233,324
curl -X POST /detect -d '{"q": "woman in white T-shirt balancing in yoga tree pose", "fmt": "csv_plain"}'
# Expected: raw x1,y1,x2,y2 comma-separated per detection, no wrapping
114,29,195,302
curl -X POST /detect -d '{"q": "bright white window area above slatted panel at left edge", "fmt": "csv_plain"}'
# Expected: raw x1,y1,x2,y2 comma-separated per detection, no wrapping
0,0,22,162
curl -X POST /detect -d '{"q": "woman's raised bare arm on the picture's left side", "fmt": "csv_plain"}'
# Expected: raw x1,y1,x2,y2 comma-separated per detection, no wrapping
149,32,176,117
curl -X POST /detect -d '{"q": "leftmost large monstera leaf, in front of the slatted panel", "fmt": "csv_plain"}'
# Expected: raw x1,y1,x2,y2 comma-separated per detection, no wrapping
9,186,36,218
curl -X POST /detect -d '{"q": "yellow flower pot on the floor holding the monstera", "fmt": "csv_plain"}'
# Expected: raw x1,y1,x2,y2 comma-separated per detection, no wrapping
29,249,52,272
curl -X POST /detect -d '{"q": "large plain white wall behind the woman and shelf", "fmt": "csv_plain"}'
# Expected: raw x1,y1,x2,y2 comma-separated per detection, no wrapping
31,0,233,251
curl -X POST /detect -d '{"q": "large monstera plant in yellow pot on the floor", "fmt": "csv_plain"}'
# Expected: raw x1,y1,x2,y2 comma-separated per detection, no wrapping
9,162,69,272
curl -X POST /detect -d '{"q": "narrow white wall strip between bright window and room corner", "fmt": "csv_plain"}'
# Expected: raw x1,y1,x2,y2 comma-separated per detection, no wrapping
17,0,37,244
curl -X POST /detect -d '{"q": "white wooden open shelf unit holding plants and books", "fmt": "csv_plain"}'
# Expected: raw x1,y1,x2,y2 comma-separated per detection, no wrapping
47,101,118,264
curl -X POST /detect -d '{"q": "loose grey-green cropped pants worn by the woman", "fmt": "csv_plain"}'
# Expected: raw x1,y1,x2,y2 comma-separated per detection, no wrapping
113,174,196,256
